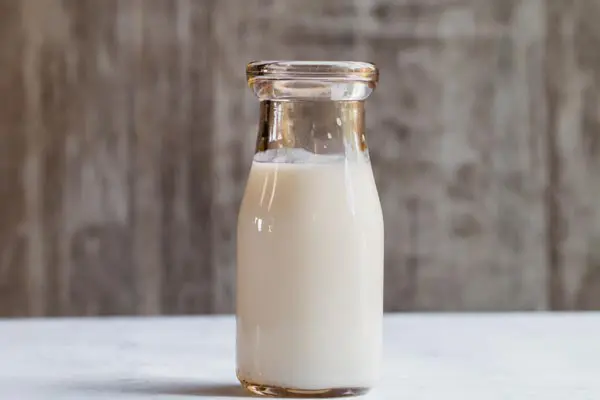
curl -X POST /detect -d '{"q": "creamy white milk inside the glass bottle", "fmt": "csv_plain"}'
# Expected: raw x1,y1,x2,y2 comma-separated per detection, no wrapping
237,150,383,390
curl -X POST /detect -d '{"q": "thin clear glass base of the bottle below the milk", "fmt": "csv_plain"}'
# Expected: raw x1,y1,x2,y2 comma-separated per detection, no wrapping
238,378,370,398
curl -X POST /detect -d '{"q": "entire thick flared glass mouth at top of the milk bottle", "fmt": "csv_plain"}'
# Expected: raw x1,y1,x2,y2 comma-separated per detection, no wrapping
246,61,379,101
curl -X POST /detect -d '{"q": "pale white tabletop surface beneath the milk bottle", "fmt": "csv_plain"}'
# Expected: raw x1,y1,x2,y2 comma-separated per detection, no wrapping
0,313,600,400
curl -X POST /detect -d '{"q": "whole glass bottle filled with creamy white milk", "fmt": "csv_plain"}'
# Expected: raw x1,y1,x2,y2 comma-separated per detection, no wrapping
237,61,383,397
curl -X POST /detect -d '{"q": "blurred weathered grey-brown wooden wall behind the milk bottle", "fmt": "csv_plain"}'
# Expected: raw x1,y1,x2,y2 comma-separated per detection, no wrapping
0,0,600,316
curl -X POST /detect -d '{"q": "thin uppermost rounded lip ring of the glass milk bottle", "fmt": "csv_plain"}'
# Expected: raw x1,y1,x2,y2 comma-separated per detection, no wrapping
246,60,379,84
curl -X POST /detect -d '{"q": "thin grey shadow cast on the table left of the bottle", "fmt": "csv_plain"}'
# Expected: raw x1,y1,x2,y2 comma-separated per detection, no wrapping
66,380,256,398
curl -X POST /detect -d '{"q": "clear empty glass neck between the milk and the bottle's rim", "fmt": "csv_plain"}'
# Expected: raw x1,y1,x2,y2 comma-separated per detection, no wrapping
256,100,368,157
